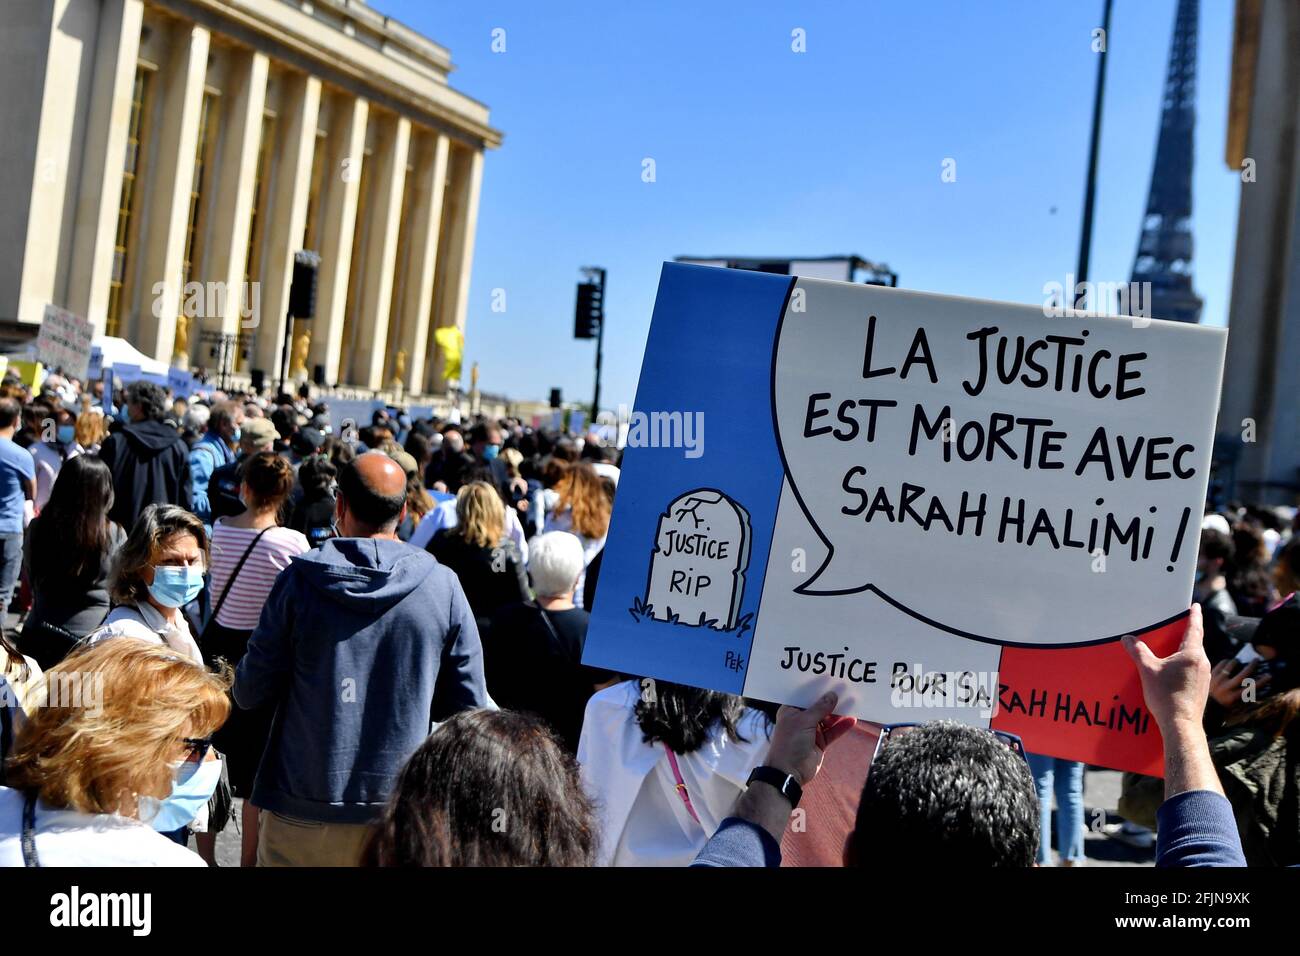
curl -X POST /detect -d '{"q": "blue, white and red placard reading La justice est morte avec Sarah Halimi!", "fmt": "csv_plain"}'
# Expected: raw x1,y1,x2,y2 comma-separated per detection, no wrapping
584,264,1226,774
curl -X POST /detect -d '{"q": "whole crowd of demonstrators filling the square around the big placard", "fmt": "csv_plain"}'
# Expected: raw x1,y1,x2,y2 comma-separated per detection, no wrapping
0,376,1300,866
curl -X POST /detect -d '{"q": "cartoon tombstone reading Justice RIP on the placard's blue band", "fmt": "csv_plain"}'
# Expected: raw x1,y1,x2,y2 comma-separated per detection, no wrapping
645,488,750,631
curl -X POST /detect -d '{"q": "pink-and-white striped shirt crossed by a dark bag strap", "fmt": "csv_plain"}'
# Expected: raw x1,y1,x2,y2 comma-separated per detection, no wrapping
209,519,311,631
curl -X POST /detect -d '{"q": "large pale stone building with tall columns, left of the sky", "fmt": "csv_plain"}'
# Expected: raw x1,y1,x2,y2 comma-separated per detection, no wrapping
0,0,502,394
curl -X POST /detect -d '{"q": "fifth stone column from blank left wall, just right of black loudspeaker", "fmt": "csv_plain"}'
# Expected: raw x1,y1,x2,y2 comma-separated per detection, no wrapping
307,99,369,384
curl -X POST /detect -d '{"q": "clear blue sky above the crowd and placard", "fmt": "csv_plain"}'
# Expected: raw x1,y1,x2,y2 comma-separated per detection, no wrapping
372,0,1240,407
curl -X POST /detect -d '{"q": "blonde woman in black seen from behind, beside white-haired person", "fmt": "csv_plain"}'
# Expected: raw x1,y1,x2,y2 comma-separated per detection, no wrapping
428,481,528,636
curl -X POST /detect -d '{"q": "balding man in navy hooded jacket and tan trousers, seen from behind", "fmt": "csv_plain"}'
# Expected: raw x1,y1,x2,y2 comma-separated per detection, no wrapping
234,451,489,866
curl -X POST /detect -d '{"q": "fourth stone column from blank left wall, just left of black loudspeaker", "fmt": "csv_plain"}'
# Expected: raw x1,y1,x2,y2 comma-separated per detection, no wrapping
252,74,321,382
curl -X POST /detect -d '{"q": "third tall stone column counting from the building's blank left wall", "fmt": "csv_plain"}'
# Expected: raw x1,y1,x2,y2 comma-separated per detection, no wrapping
191,49,270,345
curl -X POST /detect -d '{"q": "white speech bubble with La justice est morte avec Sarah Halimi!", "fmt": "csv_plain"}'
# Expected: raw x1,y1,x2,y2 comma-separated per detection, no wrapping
772,278,1226,646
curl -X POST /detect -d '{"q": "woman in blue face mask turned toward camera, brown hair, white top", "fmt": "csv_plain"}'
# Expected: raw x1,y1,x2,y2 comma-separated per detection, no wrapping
88,505,208,663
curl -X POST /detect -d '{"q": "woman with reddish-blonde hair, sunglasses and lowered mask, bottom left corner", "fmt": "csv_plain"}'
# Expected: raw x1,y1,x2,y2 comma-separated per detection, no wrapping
0,637,230,866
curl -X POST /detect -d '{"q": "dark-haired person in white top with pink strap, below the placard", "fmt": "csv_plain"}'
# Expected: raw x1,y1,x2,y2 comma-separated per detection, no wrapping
577,679,771,866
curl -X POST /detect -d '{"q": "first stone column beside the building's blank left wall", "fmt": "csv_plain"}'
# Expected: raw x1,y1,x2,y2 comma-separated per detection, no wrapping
68,0,144,334
